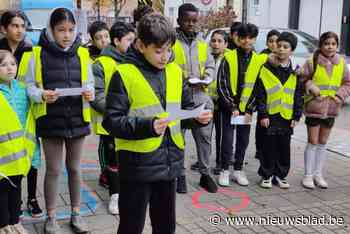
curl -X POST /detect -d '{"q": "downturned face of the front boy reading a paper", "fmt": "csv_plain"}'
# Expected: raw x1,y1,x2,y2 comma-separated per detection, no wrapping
137,40,172,70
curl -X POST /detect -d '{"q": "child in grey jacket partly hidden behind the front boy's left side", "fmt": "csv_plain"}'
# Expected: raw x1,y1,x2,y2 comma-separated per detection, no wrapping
91,22,135,214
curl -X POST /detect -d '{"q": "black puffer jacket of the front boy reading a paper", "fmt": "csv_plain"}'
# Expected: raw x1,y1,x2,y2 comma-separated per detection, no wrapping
102,46,201,182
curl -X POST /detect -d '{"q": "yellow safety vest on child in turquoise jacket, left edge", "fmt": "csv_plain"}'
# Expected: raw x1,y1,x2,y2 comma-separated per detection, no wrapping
0,93,36,180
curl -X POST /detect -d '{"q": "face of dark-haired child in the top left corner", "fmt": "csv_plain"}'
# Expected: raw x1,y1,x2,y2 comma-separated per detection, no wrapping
4,17,26,43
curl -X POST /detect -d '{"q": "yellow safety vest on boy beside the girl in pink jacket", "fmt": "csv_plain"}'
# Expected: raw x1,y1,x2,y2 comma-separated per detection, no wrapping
260,66,297,120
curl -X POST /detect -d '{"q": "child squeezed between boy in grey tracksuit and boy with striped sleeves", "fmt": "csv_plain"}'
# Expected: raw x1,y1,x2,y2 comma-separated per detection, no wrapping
209,30,228,175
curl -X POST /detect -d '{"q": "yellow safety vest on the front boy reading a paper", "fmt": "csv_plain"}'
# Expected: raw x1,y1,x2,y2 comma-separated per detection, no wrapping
115,63,185,153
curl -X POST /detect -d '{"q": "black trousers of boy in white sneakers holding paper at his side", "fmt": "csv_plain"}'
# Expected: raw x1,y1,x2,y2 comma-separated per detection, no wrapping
219,111,250,170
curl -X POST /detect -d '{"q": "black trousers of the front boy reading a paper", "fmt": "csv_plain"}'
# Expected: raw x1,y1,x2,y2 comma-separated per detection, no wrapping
118,180,176,234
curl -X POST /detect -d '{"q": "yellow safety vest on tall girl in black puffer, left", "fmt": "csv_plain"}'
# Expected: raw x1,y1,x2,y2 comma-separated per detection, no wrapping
33,46,91,122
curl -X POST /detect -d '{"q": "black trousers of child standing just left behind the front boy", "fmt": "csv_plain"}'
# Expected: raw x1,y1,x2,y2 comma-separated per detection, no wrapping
98,135,120,195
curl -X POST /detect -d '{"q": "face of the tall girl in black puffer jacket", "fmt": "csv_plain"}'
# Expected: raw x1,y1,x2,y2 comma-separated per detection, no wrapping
52,20,75,48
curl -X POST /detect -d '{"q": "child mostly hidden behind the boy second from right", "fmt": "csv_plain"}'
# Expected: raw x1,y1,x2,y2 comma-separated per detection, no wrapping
255,29,281,159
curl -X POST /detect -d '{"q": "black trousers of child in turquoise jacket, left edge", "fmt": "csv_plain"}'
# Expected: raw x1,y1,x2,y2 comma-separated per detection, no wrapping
0,176,22,228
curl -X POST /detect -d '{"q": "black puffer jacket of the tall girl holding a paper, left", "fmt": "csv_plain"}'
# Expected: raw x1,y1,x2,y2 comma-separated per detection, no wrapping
37,30,90,138
